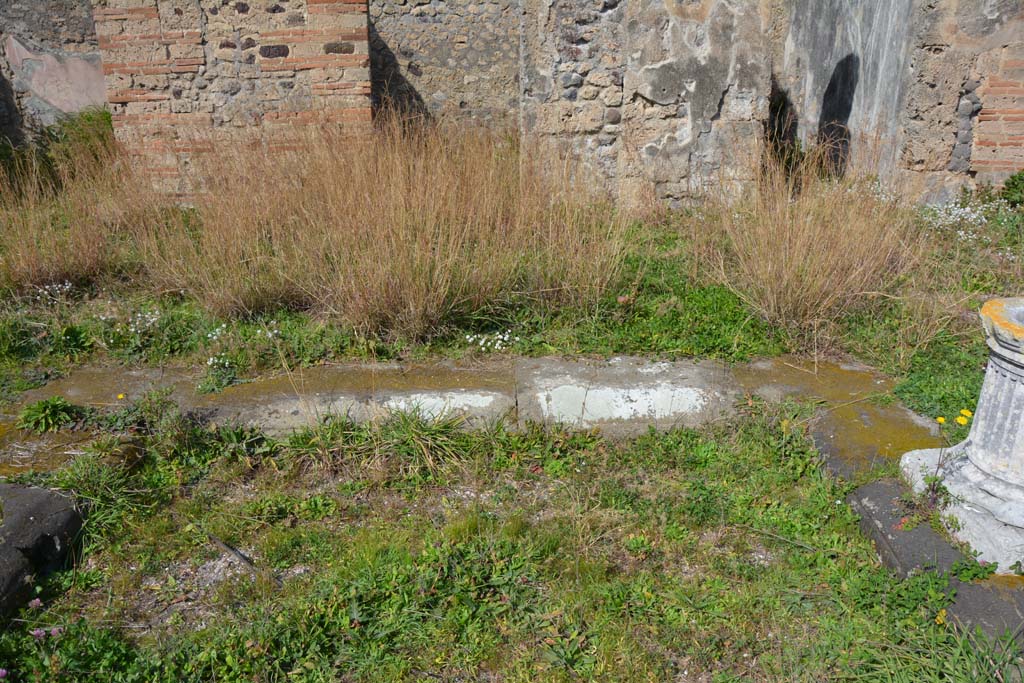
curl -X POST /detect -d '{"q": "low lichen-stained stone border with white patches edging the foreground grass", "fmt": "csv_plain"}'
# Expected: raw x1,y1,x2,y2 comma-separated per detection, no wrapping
0,356,1024,642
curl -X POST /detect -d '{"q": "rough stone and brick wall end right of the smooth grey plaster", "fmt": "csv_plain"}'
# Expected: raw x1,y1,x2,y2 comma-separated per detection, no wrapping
898,0,1024,192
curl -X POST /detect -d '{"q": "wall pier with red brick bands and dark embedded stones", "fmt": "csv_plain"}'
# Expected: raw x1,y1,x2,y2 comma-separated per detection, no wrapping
93,0,371,193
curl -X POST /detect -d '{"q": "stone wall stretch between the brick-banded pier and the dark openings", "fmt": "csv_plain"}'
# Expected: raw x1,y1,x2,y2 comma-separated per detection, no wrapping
371,0,770,200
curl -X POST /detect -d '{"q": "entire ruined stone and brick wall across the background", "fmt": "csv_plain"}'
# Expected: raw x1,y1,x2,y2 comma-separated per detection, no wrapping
0,0,1024,201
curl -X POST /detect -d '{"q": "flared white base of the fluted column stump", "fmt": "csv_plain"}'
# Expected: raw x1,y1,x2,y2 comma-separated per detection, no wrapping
900,443,1024,573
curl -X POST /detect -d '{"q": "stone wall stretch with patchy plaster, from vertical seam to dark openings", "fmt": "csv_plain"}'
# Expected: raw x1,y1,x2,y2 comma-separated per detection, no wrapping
522,0,770,200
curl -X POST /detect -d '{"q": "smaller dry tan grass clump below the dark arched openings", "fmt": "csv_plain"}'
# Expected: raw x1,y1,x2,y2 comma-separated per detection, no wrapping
693,146,924,341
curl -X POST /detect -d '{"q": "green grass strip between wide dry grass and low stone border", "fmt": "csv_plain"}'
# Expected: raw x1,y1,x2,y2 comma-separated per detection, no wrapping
0,228,785,401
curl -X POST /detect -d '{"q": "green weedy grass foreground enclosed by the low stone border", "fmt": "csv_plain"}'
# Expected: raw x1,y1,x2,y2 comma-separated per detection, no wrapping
0,398,1019,682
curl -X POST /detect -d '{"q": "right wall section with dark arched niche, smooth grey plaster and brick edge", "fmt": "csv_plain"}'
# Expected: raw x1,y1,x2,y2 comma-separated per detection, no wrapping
774,0,1024,201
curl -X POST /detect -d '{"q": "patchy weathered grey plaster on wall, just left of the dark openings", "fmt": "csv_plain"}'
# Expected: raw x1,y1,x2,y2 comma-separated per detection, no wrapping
620,0,771,199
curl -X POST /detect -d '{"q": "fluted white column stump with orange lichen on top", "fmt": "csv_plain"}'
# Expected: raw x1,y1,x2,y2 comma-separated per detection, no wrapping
901,299,1024,573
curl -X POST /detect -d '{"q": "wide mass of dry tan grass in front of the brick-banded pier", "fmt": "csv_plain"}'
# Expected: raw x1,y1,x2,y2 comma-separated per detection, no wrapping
39,119,623,338
